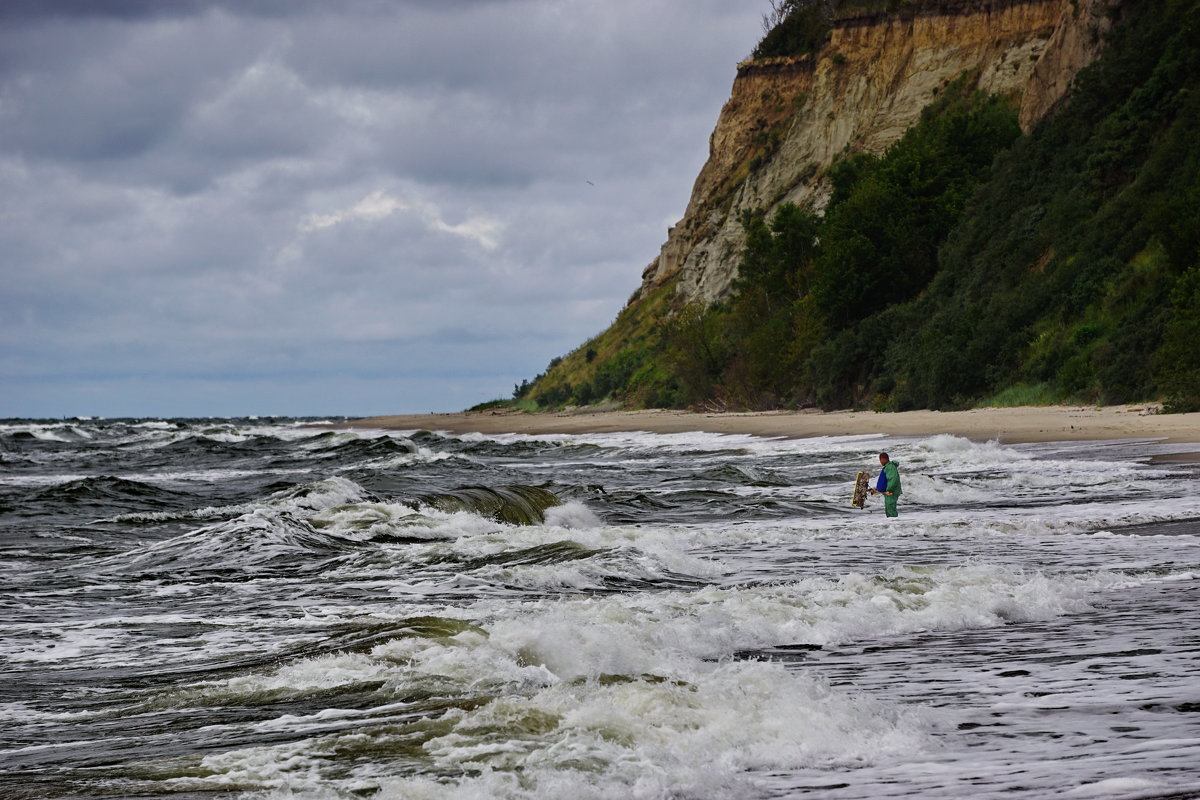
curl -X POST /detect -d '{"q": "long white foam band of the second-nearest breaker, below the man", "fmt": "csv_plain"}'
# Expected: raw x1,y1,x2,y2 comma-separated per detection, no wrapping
169,565,1123,692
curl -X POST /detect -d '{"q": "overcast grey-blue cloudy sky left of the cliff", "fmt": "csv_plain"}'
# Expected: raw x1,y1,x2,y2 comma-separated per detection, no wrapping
0,0,767,416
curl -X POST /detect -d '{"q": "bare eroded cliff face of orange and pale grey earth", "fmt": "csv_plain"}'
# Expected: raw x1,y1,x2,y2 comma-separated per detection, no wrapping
630,0,1112,303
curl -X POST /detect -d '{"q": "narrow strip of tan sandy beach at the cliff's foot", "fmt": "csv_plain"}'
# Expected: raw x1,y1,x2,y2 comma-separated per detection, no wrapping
340,405,1200,451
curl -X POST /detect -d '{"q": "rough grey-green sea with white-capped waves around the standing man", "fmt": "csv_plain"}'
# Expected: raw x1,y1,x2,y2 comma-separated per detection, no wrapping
0,419,1200,800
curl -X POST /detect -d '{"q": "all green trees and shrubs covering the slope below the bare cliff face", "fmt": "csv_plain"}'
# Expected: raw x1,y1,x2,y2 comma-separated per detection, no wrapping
517,0,1200,410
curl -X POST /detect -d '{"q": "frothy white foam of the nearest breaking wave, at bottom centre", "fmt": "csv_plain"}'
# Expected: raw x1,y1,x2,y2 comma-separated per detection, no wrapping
408,663,929,798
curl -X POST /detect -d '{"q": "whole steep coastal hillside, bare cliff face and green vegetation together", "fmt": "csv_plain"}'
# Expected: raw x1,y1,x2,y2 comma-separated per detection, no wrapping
516,0,1200,410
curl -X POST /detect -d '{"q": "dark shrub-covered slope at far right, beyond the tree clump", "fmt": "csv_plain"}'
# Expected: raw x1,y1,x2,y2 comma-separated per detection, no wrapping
873,0,1200,410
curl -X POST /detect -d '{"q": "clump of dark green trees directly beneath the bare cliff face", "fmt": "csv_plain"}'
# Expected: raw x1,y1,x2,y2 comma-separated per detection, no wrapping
665,80,1020,408
